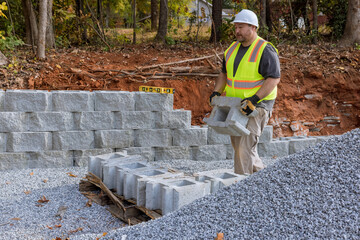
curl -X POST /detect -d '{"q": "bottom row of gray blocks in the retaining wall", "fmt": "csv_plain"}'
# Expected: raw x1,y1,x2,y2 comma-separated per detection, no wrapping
0,134,329,170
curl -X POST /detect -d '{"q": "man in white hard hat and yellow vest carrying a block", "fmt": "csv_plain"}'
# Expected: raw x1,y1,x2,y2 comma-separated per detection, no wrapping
210,9,280,174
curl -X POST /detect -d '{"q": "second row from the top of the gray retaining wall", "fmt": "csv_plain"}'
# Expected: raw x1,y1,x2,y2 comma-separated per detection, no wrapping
0,110,191,132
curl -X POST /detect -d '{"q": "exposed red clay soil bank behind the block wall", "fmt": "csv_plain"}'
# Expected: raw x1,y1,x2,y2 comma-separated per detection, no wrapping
0,44,360,137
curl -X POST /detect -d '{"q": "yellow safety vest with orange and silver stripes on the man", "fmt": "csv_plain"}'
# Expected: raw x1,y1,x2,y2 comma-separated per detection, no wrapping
224,37,277,102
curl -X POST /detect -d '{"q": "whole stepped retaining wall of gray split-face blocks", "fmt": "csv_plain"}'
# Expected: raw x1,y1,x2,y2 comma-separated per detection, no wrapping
0,90,330,170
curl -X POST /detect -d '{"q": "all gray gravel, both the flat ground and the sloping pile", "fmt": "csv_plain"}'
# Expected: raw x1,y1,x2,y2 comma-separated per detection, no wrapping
0,129,360,240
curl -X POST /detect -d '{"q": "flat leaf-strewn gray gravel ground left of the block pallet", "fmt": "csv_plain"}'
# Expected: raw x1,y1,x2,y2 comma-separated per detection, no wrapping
0,168,124,240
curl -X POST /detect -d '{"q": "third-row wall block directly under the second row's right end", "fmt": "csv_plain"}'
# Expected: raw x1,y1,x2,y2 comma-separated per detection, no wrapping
172,127,208,147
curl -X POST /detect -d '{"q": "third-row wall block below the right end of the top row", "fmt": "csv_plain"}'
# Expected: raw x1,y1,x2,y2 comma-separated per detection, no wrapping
135,129,172,147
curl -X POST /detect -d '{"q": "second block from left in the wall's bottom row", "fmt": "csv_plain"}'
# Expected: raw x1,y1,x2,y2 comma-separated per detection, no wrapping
29,151,73,168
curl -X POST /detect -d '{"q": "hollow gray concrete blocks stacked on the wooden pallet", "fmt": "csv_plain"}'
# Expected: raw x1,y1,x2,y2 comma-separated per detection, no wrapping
88,151,246,215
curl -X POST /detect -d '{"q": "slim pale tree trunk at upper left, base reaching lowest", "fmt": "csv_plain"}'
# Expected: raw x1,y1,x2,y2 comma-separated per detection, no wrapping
37,0,48,59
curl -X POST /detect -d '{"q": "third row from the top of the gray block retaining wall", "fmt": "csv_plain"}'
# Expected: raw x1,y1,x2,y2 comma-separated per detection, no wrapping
0,124,270,152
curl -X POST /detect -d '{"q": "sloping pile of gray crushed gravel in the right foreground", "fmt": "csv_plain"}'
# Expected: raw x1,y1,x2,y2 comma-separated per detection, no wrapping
80,129,360,240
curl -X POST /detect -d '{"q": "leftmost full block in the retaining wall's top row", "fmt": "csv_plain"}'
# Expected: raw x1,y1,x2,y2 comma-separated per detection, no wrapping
4,90,51,112
